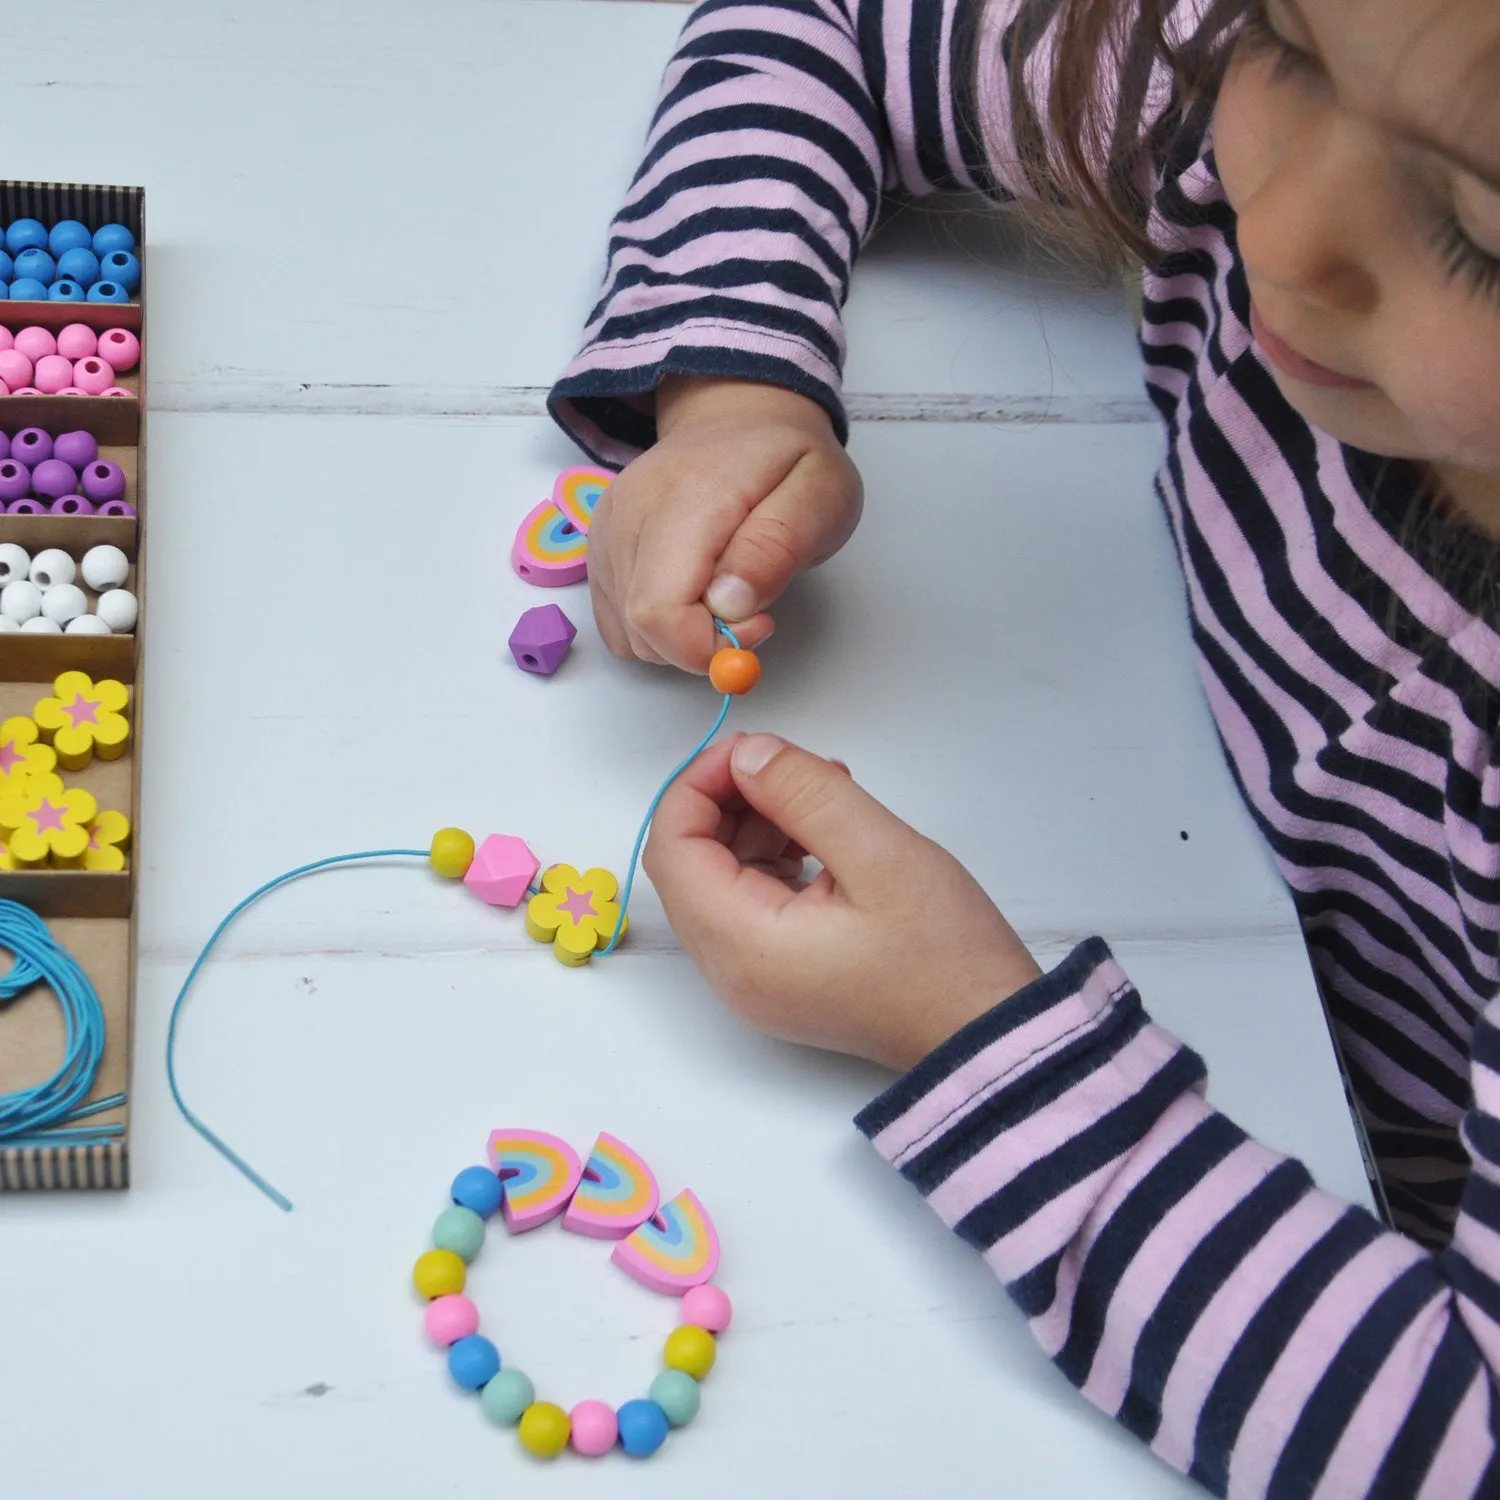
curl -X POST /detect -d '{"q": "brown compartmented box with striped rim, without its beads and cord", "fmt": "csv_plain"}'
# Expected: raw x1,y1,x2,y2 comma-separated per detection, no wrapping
0,182,149,1190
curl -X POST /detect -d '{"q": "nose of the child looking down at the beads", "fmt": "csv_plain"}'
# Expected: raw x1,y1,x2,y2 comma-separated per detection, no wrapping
1239,117,1380,314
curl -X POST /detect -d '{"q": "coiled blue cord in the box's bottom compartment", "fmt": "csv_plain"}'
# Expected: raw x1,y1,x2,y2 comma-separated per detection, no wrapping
0,900,125,1148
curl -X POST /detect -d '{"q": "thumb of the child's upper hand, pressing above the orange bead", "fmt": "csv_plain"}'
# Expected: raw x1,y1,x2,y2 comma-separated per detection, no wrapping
704,459,858,624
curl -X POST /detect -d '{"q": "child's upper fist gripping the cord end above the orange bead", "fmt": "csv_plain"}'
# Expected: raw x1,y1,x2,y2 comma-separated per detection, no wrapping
588,375,864,672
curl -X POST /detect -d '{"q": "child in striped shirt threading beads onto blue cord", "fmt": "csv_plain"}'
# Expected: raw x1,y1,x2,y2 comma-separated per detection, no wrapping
554,0,1500,1497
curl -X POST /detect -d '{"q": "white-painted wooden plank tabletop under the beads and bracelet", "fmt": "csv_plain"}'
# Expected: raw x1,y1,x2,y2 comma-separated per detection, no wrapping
0,0,1368,1500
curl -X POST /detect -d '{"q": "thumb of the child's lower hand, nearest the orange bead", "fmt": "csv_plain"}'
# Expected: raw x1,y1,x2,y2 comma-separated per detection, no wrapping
729,735,920,897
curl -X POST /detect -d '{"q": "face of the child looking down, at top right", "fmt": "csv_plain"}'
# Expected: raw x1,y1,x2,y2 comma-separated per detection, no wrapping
1214,0,1500,498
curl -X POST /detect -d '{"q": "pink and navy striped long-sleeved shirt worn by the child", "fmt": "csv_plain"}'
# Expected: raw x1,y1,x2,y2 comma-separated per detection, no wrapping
552,0,1500,1500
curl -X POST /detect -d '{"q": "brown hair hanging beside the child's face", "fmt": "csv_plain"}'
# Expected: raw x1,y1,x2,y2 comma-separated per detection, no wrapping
996,0,1256,266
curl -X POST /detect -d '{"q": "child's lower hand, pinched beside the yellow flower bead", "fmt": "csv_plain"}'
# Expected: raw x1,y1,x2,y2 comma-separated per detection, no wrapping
645,735,1041,1070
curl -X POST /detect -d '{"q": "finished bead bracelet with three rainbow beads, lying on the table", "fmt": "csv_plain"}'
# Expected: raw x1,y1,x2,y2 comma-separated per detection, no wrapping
411,1130,732,1458
